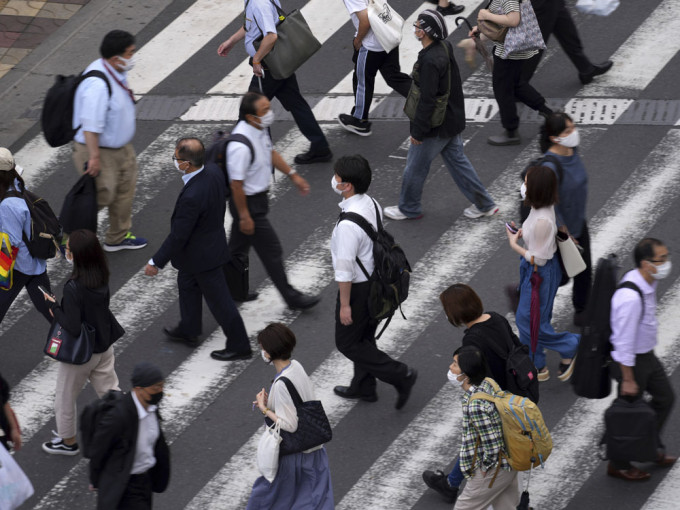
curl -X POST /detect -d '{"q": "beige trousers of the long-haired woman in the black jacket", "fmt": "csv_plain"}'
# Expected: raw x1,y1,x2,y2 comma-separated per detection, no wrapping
54,346,120,439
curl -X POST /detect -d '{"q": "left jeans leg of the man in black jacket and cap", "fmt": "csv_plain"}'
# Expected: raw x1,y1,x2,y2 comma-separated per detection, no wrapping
399,138,449,218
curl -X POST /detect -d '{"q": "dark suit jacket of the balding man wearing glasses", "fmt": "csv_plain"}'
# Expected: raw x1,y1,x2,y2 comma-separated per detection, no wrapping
153,168,229,273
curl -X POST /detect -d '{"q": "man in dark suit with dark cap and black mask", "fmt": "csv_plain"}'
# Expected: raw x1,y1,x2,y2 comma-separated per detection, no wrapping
90,362,170,510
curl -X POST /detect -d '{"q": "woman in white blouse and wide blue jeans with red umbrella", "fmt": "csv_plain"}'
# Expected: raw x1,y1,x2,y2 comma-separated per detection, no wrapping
507,166,580,381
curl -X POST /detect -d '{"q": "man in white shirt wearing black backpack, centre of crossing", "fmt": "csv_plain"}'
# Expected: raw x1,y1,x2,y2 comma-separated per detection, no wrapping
331,154,418,409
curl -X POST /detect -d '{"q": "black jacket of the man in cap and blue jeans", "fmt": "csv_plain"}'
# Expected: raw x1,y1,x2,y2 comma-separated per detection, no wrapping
411,41,465,141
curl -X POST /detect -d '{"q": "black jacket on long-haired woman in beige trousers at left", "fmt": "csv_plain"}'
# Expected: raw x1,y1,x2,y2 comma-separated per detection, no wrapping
50,280,125,353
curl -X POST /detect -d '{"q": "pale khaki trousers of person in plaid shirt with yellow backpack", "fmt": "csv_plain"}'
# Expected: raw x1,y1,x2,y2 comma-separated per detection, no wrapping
453,467,519,510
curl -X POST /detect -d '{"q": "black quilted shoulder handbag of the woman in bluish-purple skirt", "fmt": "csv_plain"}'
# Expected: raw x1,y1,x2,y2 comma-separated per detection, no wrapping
265,377,333,455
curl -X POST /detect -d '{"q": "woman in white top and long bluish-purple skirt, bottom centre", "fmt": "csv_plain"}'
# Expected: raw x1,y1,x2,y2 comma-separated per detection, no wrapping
247,322,334,510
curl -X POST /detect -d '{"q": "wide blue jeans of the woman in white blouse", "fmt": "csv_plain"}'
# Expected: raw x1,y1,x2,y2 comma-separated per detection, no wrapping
515,255,581,370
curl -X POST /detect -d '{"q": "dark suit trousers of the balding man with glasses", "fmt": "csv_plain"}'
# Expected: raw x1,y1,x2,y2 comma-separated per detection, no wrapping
177,266,250,352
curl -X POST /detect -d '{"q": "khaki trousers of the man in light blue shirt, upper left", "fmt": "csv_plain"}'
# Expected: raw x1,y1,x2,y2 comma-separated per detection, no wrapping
73,142,137,244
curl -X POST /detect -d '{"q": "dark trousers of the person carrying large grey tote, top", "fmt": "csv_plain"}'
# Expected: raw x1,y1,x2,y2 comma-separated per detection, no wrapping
248,69,328,151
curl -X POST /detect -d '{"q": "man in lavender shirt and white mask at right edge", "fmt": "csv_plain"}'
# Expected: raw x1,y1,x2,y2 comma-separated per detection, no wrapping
607,237,677,481
